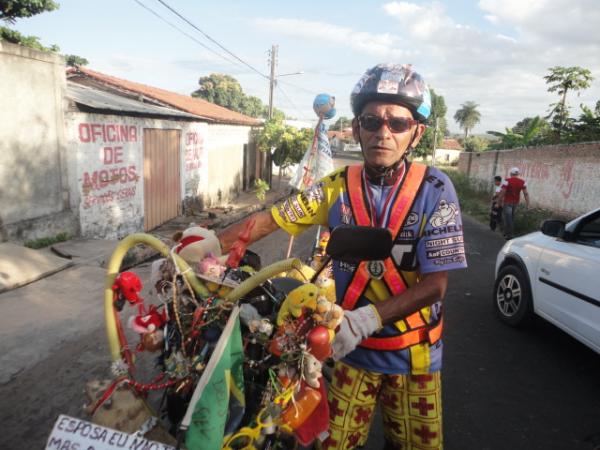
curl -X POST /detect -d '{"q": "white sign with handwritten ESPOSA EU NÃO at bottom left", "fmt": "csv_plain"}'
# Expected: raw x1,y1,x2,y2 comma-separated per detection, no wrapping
46,414,174,450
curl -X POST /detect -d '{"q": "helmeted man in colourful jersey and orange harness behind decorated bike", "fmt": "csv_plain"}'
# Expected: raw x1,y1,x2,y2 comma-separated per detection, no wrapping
221,64,466,449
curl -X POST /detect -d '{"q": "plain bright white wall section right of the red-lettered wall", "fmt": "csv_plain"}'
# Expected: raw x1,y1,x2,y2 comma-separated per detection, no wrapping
205,124,250,206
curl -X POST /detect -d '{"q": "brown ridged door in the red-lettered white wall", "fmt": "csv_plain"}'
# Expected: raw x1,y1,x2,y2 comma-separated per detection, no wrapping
144,128,181,231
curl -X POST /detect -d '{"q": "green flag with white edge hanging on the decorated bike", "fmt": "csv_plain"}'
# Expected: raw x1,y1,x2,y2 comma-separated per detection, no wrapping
181,306,245,450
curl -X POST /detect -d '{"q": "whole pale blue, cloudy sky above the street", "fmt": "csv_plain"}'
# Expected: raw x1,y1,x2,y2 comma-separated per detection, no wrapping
14,0,600,133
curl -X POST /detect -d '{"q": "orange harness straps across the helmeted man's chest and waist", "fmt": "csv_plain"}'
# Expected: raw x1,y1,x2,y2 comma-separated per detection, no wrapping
342,163,442,350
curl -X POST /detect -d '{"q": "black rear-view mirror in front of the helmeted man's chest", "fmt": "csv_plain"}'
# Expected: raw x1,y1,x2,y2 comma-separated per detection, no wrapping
326,225,393,264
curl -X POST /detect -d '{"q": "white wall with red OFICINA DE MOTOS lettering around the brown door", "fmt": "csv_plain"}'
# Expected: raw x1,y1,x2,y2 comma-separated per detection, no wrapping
66,112,213,238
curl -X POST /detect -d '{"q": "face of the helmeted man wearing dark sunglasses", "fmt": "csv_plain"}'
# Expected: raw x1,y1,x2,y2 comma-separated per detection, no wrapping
352,102,425,167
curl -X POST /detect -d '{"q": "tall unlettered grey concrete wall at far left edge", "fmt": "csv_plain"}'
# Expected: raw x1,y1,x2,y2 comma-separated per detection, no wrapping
0,42,77,241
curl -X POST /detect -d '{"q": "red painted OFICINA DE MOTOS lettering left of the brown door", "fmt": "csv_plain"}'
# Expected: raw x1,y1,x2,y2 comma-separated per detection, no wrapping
78,122,140,209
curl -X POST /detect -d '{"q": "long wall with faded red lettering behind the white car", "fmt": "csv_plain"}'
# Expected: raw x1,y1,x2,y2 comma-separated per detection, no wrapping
458,143,600,215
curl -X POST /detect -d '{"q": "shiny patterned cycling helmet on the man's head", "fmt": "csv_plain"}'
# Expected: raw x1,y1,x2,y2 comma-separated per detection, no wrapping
350,63,431,122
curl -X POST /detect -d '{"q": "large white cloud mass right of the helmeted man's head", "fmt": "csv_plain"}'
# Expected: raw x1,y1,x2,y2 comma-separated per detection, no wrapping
382,0,600,131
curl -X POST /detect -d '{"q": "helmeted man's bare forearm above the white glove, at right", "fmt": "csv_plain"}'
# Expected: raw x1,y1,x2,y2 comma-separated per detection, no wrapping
375,271,448,325
